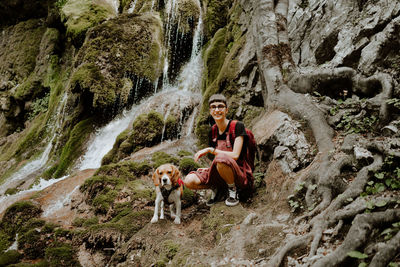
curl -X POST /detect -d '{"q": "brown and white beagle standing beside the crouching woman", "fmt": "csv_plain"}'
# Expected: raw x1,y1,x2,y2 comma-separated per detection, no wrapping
151,164,183,224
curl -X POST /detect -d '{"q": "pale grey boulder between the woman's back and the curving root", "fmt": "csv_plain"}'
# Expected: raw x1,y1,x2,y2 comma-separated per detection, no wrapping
253,111,312,173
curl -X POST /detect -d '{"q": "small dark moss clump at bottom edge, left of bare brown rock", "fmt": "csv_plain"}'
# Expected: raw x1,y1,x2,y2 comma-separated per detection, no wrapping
45,246,81,266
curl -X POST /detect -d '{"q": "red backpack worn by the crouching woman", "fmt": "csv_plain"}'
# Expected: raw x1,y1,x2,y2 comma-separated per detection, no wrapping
211,120,257,171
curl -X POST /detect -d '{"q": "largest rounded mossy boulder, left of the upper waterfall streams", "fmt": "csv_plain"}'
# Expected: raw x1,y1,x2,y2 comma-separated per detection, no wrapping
71,14,162,115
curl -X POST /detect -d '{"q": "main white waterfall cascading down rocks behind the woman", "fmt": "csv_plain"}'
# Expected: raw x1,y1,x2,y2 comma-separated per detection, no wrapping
78,0,203,170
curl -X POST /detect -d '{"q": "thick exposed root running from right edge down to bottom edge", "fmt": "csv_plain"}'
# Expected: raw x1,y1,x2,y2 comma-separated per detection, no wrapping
313,209,400,267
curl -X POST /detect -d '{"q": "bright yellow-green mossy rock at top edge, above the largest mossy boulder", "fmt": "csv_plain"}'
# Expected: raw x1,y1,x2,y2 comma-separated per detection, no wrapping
60,0,115,47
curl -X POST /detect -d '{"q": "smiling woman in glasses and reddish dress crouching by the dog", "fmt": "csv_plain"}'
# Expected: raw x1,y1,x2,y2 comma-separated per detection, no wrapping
185,94,253,206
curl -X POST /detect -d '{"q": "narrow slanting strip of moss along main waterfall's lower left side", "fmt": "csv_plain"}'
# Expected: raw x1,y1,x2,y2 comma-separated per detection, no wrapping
54,118,93,177
